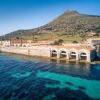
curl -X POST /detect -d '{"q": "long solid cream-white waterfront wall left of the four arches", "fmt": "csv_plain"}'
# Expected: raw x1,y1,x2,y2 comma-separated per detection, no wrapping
1,46,50,57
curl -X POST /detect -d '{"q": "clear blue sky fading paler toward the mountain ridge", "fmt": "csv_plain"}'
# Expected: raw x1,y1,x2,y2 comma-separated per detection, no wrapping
0,0,100,35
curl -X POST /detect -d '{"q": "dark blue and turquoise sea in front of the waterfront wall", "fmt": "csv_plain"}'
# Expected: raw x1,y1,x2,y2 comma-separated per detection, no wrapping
0,53,100,100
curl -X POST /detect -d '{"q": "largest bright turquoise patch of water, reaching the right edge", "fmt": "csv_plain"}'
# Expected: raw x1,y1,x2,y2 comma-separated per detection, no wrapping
36,70,100,99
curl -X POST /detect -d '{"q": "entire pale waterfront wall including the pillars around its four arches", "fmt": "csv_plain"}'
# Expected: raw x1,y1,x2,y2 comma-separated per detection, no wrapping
1,45,96,62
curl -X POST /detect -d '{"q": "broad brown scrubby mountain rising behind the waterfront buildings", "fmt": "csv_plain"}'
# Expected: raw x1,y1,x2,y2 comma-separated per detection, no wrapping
2,11,100,38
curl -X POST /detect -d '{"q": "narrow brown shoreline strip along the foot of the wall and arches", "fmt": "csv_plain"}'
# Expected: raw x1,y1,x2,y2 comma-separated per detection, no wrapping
1,52,100,64
